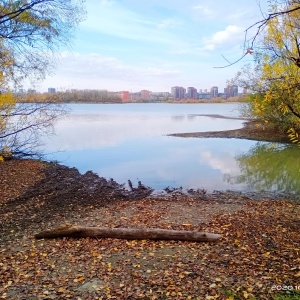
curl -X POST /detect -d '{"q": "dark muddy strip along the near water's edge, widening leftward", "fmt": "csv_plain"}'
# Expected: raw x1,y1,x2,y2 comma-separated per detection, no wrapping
0,148,299,244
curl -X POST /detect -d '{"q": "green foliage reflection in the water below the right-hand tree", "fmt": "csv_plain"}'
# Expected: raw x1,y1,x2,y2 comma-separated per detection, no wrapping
225,143,300,194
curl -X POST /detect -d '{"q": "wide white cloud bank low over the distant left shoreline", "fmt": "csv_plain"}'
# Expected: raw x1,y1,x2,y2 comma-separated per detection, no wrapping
39,52,180,91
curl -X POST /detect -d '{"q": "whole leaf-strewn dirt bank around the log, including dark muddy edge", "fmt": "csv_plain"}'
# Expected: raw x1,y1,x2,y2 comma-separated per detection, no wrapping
0,160,300,299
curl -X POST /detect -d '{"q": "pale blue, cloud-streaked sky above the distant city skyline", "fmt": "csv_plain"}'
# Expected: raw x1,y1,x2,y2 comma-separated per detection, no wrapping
37,0,267,92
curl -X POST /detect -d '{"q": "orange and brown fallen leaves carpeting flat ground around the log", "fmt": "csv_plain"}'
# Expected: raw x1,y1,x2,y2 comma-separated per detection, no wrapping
0,159,300,299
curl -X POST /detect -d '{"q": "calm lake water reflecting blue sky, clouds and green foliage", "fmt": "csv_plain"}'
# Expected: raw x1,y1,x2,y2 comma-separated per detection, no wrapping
45,103,300,193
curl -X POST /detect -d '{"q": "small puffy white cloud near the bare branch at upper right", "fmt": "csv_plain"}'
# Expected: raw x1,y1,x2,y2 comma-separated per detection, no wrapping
202,25,245,51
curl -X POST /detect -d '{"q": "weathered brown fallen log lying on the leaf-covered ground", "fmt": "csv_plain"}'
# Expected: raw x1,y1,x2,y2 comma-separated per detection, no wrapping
34,225,221,242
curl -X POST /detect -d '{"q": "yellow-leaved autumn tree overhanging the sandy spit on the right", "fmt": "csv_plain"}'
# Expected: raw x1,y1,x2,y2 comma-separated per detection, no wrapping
237,0,300,145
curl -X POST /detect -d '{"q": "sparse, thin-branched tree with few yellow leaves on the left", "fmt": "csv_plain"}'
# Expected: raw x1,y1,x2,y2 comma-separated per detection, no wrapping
0,0,85,160
